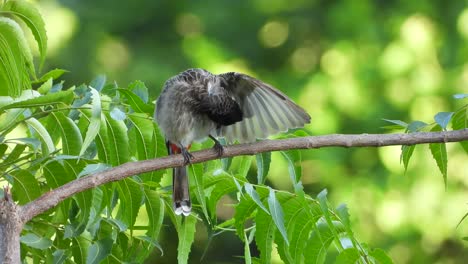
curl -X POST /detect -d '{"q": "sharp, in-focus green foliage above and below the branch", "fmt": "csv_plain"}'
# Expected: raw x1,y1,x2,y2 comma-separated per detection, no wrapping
0,0,468,263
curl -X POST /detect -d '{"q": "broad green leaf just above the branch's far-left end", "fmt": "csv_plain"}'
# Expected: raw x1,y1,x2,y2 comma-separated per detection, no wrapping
11,170,41,204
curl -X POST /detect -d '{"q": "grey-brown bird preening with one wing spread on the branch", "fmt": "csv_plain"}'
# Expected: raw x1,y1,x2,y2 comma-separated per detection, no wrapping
154,68,311,216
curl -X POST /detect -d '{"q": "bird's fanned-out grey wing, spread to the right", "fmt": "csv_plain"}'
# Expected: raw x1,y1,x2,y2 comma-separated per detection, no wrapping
217,72,310,143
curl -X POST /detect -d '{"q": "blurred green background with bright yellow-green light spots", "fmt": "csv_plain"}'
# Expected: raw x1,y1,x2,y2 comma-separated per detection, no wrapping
33,0,468,263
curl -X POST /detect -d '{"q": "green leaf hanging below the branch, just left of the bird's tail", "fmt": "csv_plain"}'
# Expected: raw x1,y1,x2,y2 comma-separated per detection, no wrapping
144,188,164,240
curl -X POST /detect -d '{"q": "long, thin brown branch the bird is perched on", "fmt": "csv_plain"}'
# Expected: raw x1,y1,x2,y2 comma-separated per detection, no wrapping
19,129,468,223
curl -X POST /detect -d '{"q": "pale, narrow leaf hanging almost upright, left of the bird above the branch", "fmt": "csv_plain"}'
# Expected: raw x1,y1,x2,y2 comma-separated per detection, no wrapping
80,88,102,156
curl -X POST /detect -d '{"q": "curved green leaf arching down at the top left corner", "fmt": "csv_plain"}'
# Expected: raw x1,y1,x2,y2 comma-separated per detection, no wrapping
3,0,47,68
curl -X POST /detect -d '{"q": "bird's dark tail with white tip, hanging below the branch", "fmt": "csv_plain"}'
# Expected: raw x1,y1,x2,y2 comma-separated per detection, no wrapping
172,166,192,216
